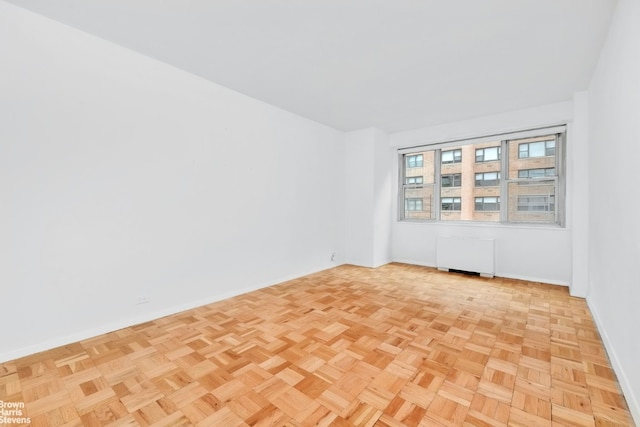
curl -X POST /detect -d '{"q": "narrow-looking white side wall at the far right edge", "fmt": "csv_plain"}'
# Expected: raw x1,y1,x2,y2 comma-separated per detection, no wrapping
587,0,640,424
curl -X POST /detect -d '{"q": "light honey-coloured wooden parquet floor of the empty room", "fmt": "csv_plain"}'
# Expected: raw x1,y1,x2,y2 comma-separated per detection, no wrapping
0,264,632,427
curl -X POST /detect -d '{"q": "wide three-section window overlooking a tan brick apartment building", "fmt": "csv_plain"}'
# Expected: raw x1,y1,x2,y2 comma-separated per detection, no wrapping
400,126,565,225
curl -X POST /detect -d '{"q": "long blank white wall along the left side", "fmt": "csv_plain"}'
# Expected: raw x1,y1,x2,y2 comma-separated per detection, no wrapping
0,2,344,360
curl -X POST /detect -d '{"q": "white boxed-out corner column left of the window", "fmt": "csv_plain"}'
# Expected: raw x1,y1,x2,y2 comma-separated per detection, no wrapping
344,128,392,267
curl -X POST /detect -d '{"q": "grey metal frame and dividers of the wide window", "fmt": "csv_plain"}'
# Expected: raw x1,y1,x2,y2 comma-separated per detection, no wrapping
397,124,567,228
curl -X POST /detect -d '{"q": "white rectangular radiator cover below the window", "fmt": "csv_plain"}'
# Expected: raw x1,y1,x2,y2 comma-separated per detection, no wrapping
436,236,495,277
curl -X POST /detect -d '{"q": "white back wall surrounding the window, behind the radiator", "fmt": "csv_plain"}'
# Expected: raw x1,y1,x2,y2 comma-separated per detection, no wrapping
390,102,586,286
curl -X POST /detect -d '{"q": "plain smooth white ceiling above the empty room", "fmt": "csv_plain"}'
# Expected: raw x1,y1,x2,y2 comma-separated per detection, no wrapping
3,0,616,132
